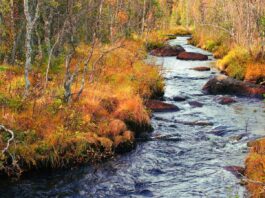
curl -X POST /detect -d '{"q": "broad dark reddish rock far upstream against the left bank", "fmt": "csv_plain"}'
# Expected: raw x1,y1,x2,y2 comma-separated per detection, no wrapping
150,45,185,57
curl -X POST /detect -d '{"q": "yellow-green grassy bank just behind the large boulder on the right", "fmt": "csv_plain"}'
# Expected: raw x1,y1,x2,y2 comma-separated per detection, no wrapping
190,30,265,84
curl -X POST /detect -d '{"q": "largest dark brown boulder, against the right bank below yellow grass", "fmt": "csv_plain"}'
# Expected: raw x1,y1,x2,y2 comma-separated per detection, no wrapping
203,75,265,98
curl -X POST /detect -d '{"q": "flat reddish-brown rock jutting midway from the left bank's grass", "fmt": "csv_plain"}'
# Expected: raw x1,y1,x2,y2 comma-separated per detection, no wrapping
145,100,180,112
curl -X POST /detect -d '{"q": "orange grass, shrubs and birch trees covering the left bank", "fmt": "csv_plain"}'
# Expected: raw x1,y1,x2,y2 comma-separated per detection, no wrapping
0,0,177,175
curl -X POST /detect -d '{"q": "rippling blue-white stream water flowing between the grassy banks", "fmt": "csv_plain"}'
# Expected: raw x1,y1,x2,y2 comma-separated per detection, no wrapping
0,37,265,198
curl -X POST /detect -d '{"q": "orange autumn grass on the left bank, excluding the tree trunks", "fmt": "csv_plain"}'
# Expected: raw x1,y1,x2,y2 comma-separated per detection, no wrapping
0,40,164,176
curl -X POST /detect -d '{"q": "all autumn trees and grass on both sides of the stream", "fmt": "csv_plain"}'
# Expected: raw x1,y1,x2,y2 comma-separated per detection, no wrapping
0,0,265,196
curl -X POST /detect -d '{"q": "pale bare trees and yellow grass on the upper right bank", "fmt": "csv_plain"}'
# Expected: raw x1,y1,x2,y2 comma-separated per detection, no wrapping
178,0,265,83
